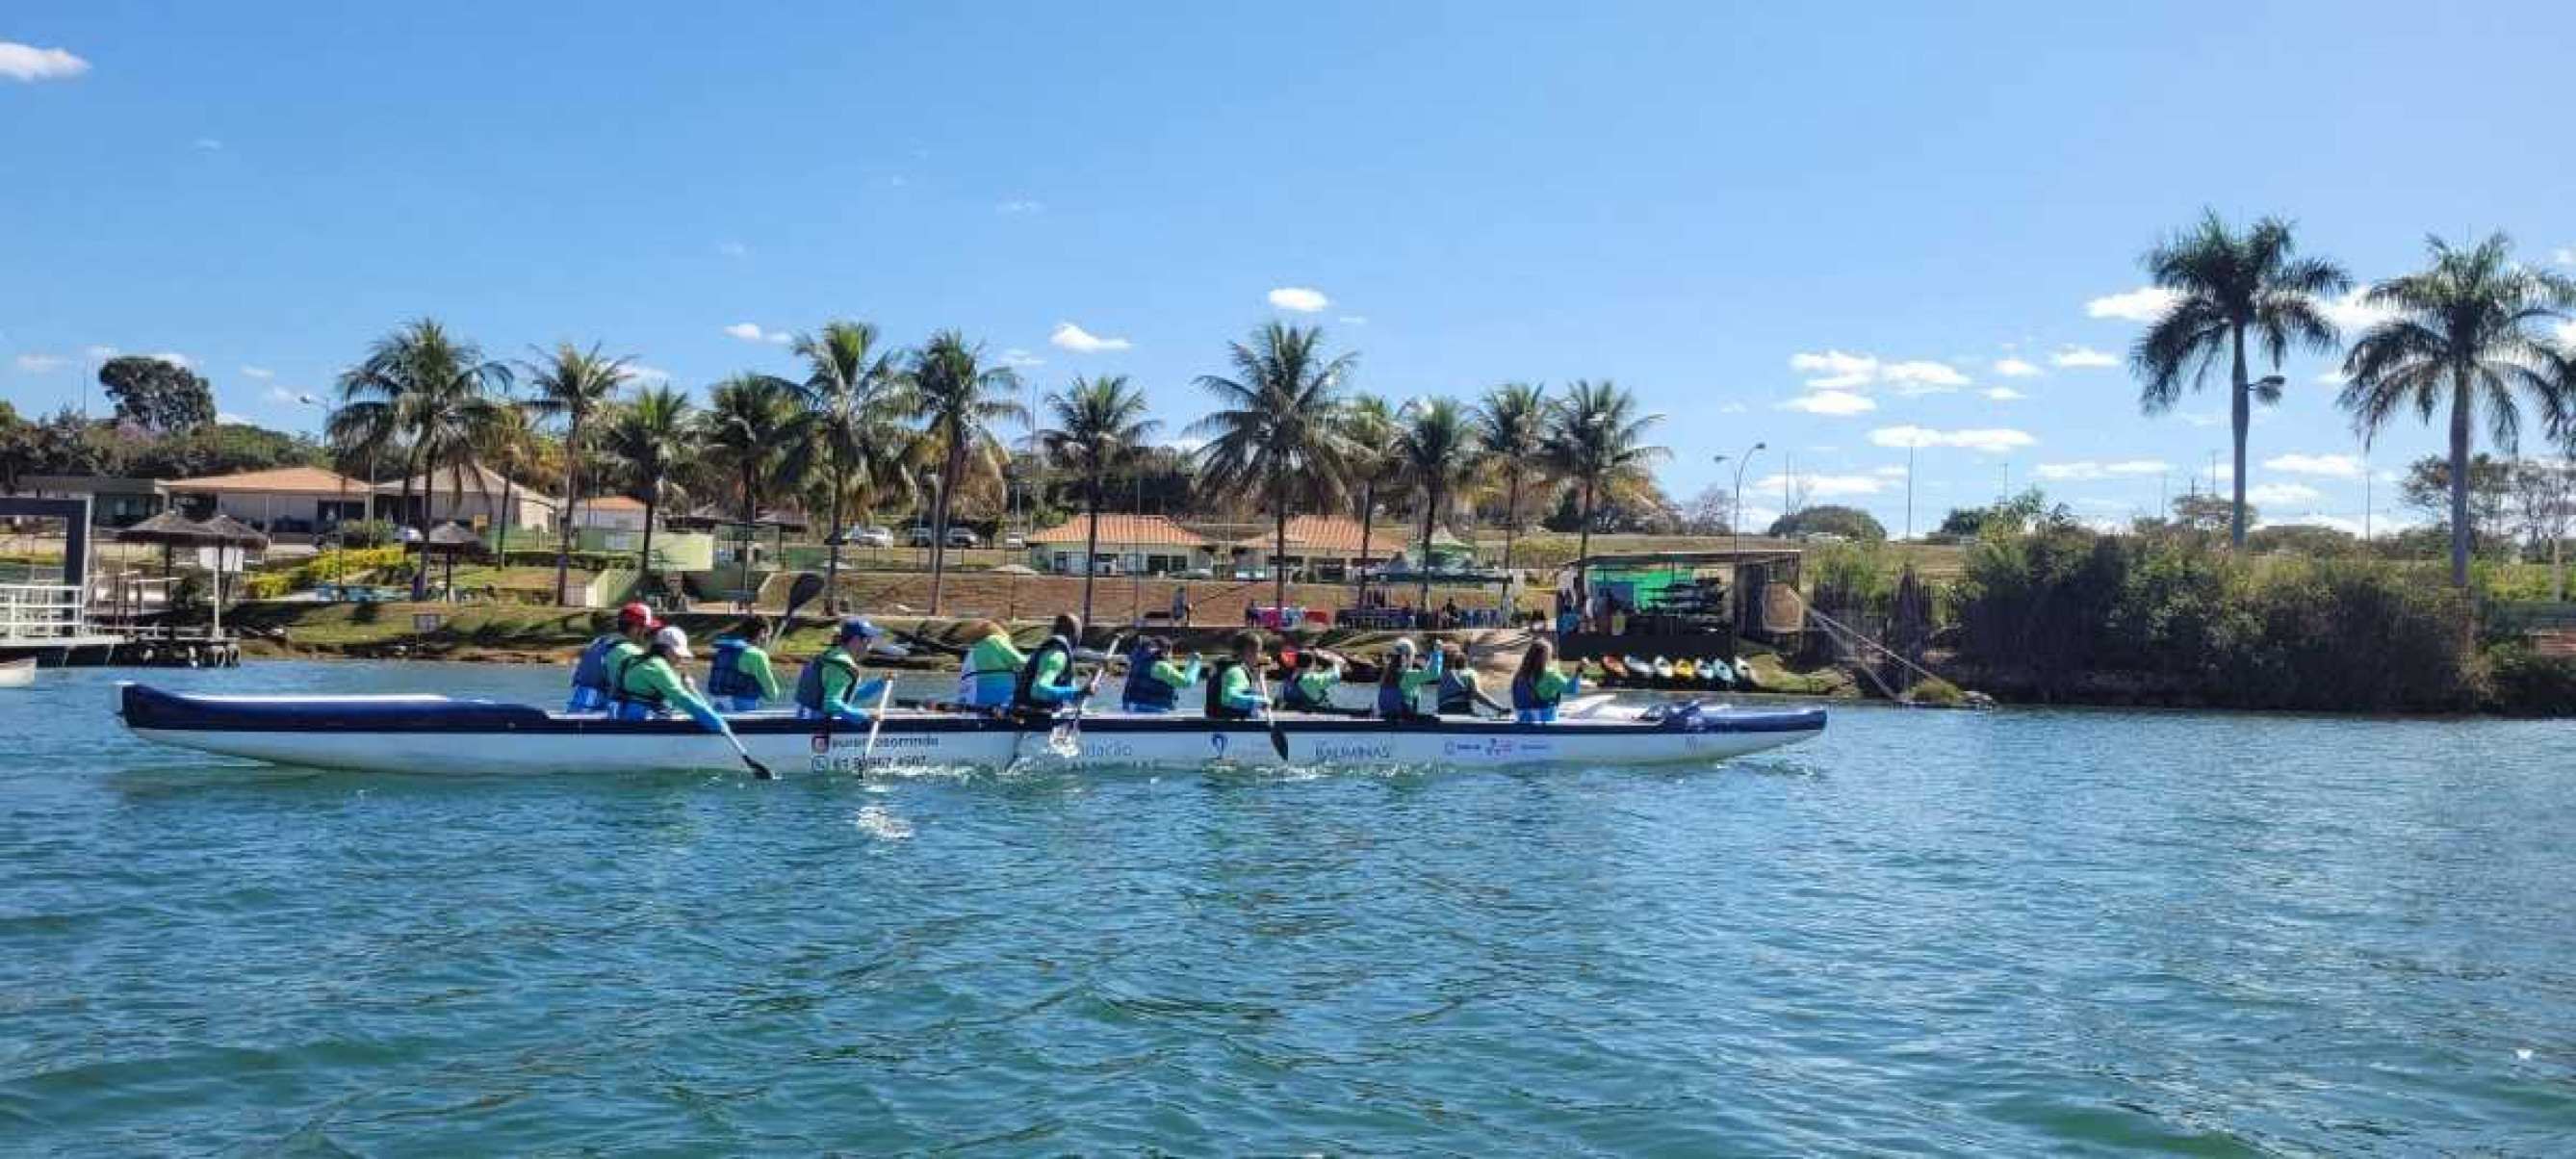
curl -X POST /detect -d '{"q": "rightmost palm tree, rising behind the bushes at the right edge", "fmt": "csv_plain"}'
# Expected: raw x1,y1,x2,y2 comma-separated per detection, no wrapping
2336,234,2576,587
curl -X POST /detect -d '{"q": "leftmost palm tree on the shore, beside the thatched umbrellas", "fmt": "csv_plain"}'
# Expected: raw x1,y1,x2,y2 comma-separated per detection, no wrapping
332,317,510,598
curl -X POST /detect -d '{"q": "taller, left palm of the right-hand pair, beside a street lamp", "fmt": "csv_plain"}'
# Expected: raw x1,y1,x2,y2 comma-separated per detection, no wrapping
2127,209,2352,549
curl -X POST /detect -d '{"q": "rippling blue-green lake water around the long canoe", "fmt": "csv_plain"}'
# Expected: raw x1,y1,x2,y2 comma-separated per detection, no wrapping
0,664,2576,1154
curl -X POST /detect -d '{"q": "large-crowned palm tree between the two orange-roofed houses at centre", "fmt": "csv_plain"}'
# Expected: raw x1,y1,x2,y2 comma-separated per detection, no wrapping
1190,322,1365,605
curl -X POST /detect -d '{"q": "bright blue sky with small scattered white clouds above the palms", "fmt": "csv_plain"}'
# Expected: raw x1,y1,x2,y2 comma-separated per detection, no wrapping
0,0,2576,528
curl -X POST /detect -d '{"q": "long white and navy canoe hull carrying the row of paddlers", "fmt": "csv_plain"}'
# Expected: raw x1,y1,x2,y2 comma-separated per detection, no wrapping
118,685,1824,773
